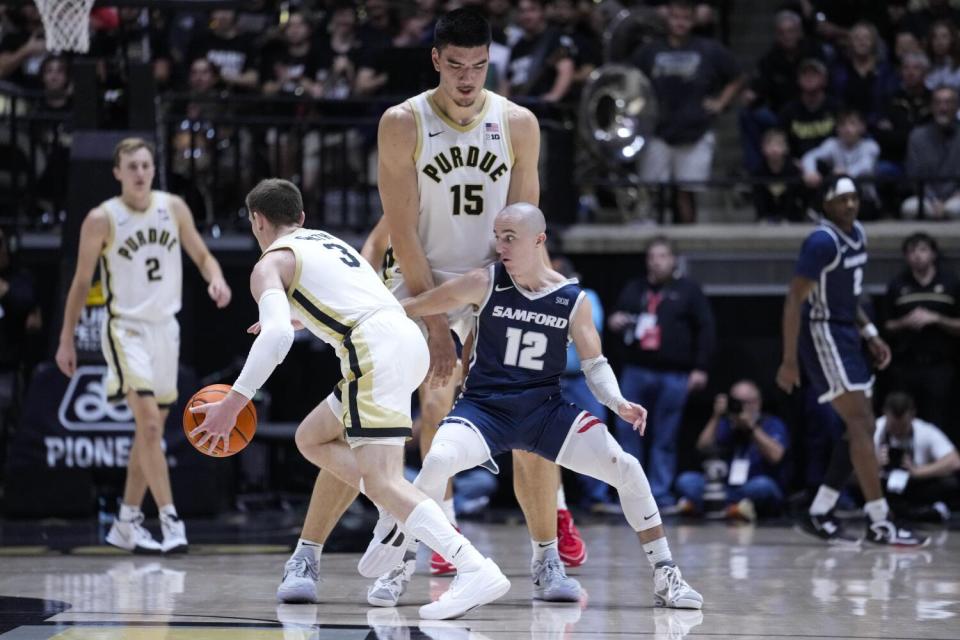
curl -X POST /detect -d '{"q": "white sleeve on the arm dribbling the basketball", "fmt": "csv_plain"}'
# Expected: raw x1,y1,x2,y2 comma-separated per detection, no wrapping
233,289,293,398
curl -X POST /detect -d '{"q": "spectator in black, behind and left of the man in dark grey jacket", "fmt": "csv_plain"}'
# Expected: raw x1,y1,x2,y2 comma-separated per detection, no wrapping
873,53,930,176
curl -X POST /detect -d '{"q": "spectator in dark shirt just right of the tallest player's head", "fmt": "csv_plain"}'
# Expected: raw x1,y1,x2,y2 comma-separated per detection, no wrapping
501,0,574,102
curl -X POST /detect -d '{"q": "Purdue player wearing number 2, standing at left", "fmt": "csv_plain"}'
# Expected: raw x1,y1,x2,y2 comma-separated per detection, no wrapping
56,138,230,553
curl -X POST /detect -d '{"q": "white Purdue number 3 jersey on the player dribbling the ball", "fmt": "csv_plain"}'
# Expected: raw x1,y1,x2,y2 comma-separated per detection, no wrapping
263,229,404,353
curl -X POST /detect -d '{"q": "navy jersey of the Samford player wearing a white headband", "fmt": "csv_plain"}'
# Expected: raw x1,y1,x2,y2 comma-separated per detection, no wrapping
795,219,867,323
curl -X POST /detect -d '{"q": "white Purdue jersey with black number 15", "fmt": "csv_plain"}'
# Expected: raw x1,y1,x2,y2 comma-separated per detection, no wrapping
398,90,514,284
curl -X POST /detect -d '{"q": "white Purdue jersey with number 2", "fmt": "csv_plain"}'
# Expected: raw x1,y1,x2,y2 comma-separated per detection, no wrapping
100,191,183,322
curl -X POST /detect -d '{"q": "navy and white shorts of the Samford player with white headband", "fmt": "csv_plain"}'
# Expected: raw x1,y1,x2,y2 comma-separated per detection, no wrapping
799,320,873,404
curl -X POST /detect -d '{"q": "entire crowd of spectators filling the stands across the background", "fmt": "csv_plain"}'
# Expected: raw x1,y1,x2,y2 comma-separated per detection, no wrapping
0,0,960,223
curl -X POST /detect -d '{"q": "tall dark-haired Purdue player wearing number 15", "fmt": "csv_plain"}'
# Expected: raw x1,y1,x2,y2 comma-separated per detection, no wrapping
277,9,585,602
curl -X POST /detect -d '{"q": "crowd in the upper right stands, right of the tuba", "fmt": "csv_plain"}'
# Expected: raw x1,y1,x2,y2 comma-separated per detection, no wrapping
740,0,960,220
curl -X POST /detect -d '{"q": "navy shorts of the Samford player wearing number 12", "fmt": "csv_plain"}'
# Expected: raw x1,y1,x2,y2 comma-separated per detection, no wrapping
440,389,589,473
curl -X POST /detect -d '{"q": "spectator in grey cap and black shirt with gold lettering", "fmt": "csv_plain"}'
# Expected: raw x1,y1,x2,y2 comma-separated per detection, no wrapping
780,58,839,161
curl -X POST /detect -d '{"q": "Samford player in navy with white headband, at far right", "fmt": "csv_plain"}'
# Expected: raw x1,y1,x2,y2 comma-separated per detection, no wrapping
777,175,927,546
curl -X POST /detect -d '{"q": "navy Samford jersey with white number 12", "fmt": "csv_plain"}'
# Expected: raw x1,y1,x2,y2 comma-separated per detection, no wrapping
464,262,583,393
